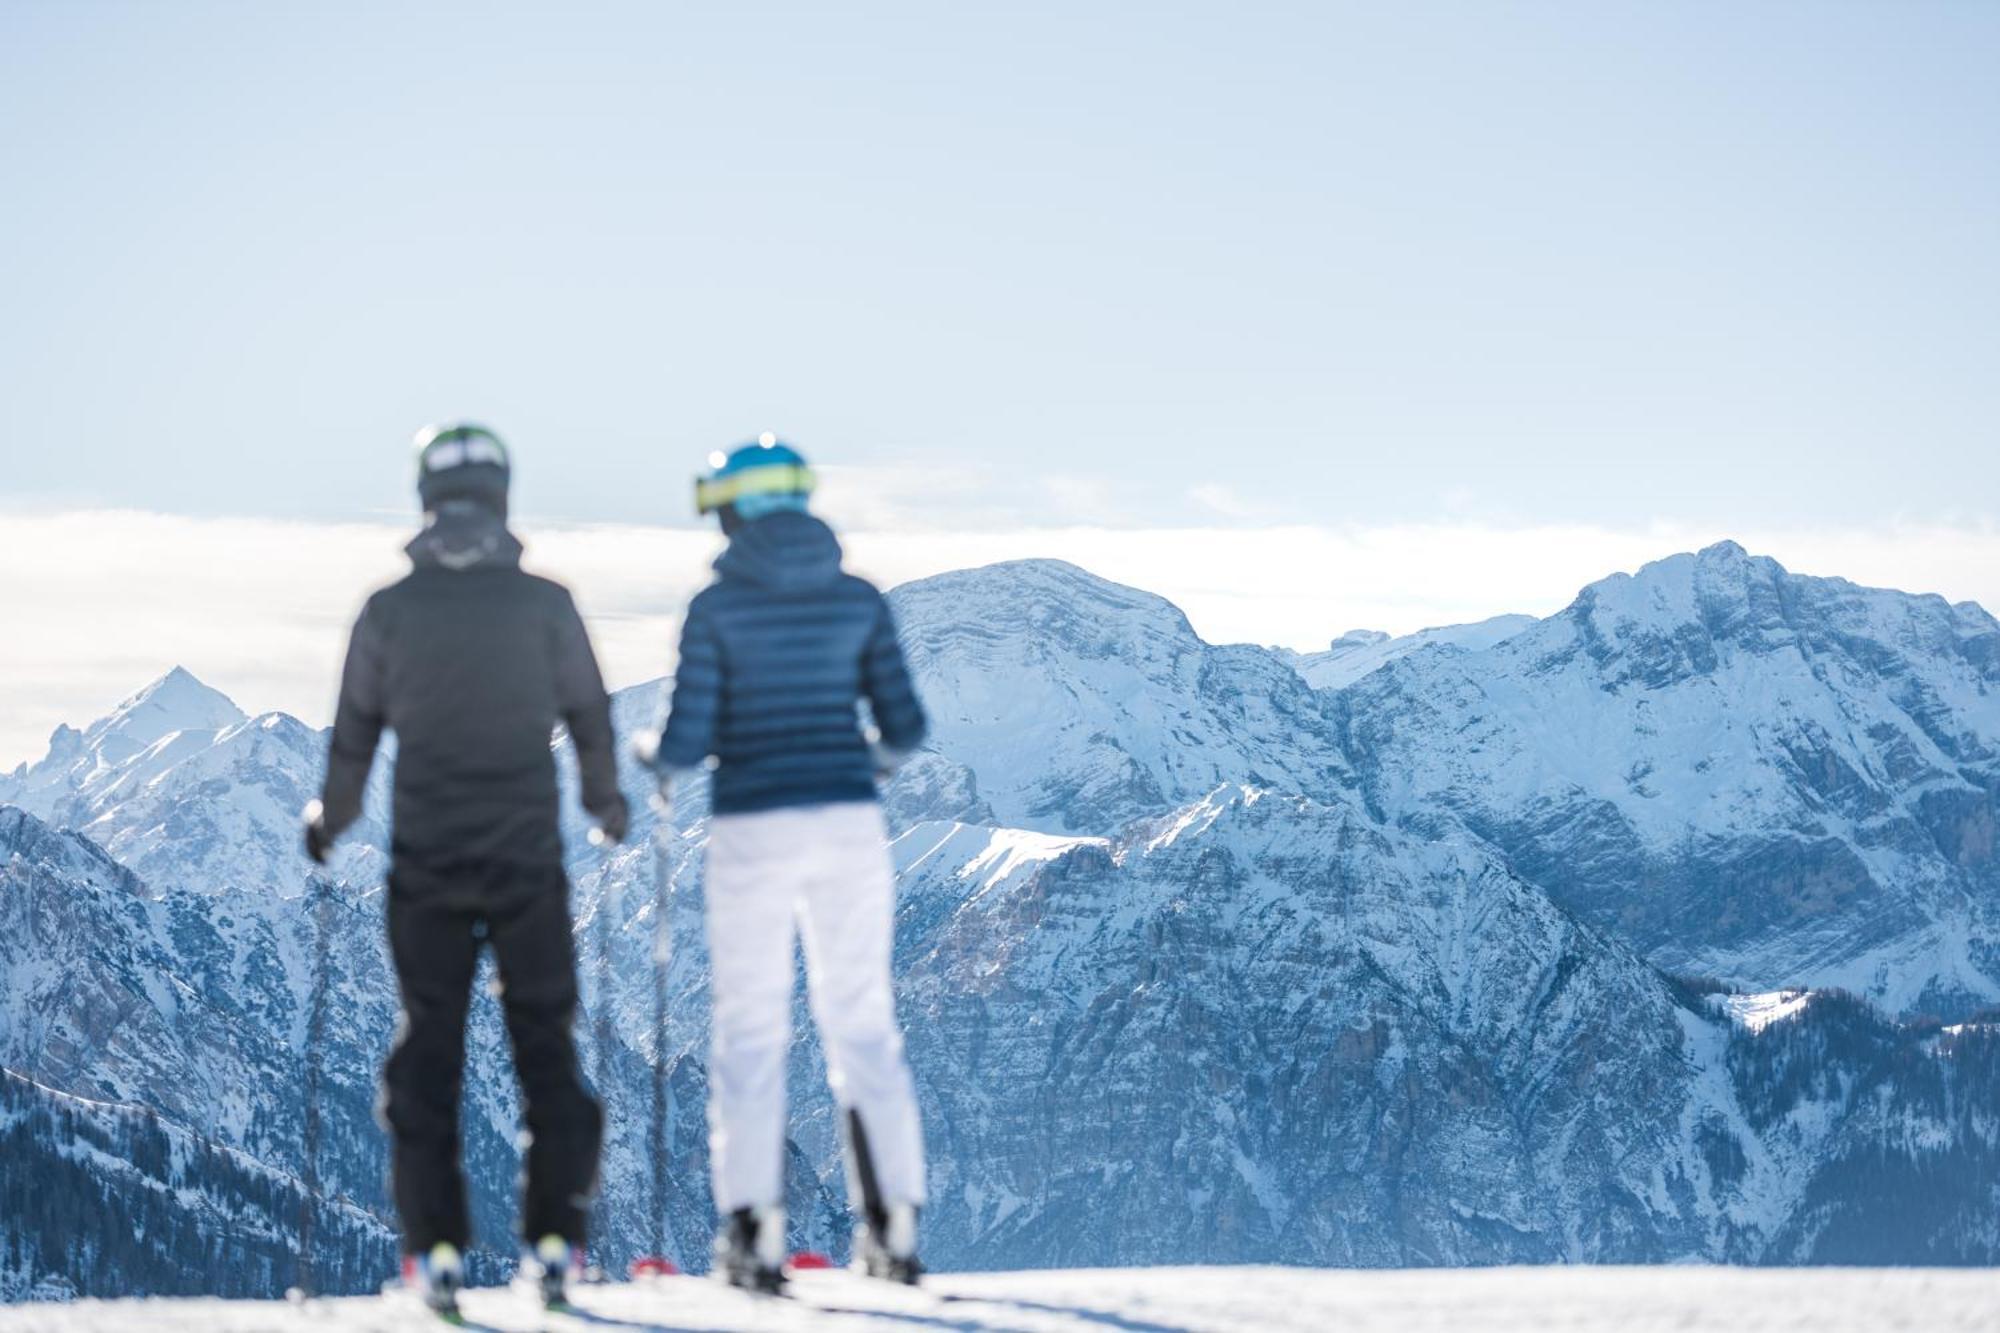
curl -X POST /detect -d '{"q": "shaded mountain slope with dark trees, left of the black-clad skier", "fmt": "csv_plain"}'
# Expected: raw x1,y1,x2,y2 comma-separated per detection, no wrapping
0,809,402,1299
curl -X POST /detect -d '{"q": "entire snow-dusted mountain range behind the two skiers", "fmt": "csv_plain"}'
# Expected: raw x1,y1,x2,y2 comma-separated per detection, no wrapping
0,546,2000,1297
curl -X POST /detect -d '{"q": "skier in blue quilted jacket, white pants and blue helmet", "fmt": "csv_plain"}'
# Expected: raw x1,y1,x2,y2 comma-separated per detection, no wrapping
654,434,926,1291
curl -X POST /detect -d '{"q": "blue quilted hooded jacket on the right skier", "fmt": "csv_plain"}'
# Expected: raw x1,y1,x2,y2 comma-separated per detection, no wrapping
660,512,926,815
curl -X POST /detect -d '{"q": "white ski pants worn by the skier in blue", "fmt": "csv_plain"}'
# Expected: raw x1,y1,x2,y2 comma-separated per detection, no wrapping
704,801,924,1215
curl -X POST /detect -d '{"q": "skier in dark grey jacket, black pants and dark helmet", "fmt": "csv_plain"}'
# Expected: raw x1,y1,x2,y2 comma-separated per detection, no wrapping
306,424,626,1311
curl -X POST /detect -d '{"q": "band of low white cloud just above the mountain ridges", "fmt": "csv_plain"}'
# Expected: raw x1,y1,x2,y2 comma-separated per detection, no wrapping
0,510,2000,767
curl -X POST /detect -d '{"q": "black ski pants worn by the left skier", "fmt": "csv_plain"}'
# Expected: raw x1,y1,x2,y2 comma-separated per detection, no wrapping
382,863,604,1253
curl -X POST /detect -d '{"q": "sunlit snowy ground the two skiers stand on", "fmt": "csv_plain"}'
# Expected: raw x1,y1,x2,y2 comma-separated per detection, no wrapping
0,1267,2000,1333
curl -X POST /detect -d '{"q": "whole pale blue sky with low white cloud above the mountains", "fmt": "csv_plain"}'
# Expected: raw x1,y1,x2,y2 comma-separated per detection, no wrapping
0,0,2000,767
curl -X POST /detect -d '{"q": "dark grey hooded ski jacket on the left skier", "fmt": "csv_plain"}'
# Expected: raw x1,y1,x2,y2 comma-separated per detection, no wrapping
320,504,626,873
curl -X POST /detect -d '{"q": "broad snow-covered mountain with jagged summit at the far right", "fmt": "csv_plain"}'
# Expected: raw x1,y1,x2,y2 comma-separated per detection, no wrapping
1340,542,2000,1017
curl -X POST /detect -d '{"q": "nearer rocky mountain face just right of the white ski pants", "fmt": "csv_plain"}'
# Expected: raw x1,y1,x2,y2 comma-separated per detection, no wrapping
888,789,1708,1265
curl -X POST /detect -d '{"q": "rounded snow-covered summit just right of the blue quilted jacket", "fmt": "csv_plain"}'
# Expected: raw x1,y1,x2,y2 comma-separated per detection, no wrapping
890,560,1348,835
